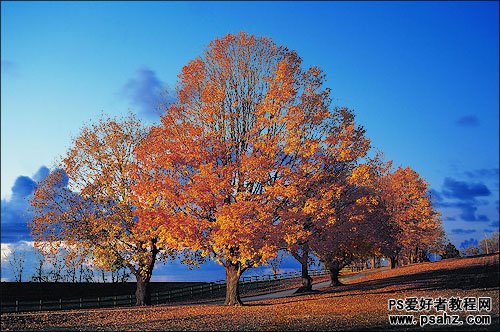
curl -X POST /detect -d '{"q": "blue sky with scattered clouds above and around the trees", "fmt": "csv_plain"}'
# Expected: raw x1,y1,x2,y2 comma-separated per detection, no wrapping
1,2,499,282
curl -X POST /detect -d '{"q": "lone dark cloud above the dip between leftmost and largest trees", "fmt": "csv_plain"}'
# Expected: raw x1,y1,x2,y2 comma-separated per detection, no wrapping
122,68,173,120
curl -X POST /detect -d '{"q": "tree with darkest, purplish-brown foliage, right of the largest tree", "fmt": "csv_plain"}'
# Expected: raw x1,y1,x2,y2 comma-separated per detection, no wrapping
311,159,390,286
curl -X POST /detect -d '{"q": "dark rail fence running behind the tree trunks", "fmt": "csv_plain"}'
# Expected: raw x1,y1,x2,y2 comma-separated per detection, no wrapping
0,270,328,312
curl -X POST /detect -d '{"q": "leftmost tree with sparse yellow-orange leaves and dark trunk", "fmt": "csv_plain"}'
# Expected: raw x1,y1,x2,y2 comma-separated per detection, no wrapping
30,115,172,305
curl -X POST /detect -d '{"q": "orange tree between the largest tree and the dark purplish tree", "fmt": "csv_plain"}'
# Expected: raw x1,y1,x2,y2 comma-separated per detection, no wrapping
280,108,370,292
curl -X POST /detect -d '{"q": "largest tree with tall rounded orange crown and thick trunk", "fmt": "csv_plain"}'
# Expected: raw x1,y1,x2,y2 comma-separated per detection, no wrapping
136,33,348,305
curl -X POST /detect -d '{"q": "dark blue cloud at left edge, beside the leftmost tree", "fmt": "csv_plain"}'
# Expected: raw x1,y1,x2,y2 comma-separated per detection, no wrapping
1,166,48,243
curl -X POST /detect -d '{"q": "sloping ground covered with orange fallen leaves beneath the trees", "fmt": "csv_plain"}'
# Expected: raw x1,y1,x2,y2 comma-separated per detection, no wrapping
1,254,499,331
